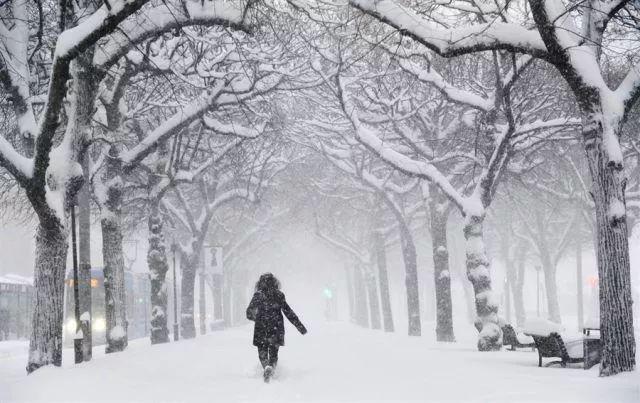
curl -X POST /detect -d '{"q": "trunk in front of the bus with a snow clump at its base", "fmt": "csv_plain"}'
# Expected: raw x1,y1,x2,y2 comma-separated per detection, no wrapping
100,146,128,353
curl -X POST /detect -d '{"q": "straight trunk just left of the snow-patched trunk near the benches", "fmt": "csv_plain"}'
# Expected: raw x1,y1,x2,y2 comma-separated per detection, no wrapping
429,204,456,342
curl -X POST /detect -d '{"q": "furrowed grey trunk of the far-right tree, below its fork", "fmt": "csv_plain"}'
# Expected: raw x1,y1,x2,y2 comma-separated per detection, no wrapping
582,116,636,376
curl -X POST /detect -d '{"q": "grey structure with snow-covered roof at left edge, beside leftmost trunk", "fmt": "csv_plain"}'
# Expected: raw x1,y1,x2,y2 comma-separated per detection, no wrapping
0,274,33,341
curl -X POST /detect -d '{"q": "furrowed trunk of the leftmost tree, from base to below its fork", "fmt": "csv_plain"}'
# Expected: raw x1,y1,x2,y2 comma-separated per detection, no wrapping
27,223,69,373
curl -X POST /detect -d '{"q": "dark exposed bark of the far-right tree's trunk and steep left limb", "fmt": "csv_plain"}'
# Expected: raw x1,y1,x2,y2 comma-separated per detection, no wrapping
529,0,636,376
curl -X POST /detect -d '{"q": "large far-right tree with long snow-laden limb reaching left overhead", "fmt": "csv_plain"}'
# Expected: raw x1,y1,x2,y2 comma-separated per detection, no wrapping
350,0,640,376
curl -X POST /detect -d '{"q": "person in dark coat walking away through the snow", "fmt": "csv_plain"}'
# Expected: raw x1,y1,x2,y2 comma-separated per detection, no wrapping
247,273,307,382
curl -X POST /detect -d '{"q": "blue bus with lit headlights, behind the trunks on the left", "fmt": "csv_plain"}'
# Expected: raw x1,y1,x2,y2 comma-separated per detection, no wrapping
64,267,151,345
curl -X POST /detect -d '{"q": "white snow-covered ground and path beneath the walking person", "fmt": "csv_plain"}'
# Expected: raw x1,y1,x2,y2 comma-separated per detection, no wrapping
0,323,640,403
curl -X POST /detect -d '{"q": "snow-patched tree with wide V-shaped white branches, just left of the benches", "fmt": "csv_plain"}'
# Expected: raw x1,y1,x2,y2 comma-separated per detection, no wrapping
308,39,570,350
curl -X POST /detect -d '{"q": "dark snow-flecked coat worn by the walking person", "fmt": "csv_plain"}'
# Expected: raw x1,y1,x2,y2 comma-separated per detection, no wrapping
247,290,307,347
